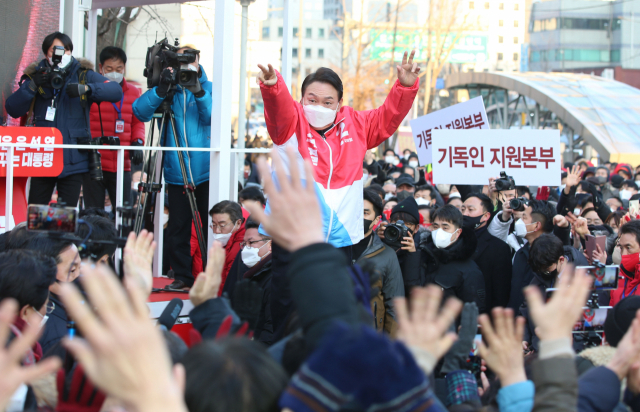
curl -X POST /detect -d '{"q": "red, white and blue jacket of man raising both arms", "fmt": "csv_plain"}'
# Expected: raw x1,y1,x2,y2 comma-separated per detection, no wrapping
260,73,419,247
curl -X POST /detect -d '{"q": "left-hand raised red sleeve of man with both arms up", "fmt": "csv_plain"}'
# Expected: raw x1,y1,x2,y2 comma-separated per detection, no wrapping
260,72,298,145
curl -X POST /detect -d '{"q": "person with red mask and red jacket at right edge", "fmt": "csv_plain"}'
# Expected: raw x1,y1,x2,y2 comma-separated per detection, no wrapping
609,220,640,306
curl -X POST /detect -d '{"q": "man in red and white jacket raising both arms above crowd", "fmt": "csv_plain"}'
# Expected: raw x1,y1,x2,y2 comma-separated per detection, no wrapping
258,51,420,247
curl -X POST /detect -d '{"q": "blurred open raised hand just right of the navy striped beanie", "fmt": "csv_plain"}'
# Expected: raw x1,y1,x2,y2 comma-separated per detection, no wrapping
393,285,462,359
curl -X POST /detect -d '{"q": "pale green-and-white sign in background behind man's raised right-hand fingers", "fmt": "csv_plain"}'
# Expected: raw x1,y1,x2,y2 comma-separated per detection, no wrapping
369,29,489,63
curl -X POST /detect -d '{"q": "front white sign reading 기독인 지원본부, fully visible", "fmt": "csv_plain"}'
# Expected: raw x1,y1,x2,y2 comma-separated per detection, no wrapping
433,130,562,186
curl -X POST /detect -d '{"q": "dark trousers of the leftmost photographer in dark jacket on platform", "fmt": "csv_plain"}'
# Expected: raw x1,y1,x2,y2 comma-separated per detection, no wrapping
28,173,88,207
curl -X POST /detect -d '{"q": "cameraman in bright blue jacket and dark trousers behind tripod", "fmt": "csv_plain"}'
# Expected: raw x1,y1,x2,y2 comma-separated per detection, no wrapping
133,47,212,289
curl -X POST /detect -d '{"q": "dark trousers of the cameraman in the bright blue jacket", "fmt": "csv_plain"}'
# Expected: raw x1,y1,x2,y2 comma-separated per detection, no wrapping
169,181,209,286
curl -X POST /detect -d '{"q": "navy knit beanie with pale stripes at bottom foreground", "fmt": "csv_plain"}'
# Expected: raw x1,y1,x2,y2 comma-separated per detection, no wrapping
279,322,434,412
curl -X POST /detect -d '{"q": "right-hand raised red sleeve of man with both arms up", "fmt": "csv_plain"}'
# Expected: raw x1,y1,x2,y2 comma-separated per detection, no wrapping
356,79,420,149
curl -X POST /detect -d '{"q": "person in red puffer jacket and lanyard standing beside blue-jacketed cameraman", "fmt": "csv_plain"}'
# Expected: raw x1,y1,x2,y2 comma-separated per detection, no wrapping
83,46,145,208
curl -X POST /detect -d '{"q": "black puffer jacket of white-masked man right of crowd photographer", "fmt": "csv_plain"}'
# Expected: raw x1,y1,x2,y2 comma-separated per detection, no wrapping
420,228,486,313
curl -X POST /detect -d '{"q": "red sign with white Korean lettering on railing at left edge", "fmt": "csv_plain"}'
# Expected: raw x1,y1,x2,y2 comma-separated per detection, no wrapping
0,127,64,177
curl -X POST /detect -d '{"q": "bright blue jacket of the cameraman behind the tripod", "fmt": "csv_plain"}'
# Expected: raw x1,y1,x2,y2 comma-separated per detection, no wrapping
132,66,212,187
